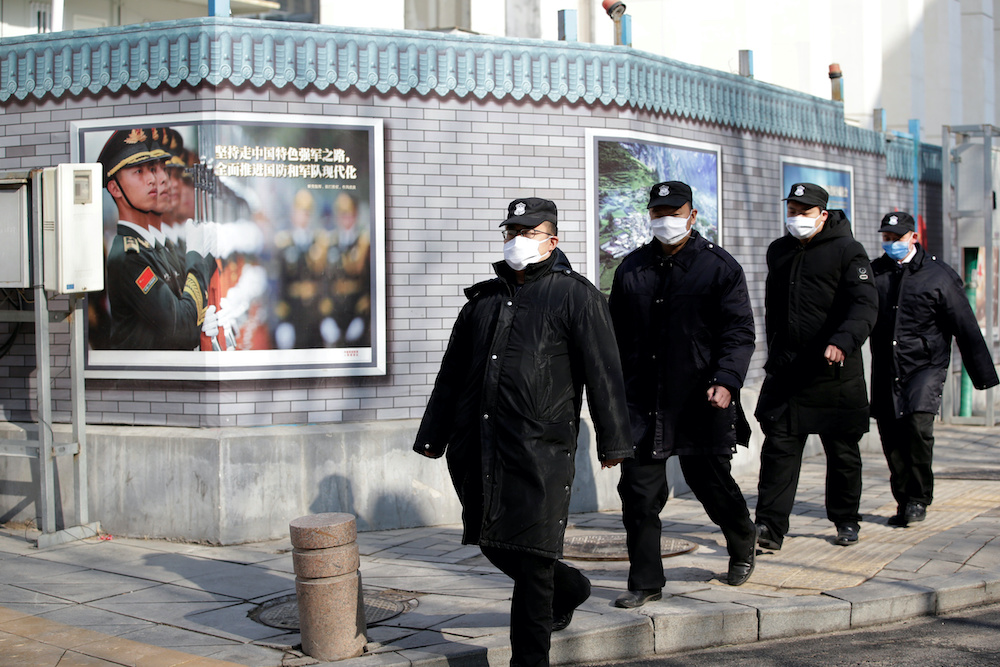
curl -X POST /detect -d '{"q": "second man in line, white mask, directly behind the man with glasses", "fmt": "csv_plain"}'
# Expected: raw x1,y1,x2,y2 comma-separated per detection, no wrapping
610,181,756,608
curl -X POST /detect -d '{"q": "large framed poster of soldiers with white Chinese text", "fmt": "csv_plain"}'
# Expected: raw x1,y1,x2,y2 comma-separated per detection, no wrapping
70,112,387,380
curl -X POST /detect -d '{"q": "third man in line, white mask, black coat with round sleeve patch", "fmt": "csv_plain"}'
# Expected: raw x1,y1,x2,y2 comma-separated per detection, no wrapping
755,183,878,550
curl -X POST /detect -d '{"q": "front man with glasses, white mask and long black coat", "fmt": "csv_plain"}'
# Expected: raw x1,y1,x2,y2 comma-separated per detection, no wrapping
413,197,632,667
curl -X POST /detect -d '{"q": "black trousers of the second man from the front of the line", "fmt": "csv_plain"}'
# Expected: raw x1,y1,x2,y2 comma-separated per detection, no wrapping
618,455,756,591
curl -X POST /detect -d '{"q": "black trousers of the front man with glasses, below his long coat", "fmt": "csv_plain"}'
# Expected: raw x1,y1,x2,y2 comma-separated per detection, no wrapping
480,546,590,667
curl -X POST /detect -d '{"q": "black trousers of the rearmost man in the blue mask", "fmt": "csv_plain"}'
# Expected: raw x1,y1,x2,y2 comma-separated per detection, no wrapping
878,412,934,510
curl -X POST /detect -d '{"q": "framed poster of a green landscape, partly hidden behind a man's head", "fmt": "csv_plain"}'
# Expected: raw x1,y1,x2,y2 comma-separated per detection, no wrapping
586,129,723,293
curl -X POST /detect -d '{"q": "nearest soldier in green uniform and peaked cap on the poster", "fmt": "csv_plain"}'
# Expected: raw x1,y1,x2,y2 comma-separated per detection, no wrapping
98,128,214,350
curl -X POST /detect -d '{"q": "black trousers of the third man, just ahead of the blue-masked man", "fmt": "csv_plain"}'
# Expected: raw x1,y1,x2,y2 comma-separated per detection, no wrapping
757,419,861,544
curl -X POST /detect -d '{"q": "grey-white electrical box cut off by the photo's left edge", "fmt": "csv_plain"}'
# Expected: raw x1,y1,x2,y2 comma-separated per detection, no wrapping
0,174,31,289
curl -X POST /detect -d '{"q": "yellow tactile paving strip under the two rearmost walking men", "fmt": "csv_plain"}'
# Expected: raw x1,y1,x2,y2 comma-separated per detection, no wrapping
744,480,1000,595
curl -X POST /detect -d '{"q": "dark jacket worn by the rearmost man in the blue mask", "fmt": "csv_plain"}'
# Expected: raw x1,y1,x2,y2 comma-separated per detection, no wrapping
871,244,998,419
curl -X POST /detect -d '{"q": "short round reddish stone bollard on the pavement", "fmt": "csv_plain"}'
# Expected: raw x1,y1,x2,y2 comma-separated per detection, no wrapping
288,513,367,661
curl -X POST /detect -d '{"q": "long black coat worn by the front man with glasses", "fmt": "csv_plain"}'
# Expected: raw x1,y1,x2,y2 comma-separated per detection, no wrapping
413,248,632,558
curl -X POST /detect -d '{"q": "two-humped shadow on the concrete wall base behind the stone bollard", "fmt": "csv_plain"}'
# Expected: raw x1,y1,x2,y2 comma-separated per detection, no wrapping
309,475,431,531
